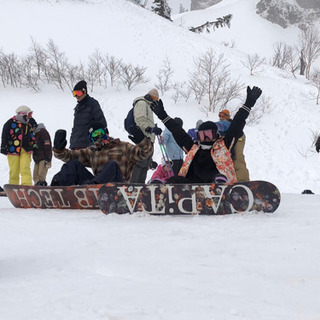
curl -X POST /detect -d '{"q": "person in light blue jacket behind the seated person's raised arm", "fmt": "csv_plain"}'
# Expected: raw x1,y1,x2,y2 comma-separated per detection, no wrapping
162,117,184,175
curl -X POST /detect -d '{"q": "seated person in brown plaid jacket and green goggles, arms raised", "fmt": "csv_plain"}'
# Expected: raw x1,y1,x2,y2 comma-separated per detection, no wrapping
51,122,153,186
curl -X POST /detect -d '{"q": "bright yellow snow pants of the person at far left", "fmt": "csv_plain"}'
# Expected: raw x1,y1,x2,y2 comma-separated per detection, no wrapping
7,148,32,186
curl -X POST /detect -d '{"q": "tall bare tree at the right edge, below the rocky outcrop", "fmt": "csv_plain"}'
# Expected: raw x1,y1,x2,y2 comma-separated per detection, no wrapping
299,26,320,79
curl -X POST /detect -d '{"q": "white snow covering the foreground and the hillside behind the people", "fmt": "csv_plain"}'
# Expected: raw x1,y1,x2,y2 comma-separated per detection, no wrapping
0,0,320,320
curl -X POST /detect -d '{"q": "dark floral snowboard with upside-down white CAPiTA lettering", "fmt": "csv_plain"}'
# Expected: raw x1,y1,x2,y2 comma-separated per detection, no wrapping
98,181,280,215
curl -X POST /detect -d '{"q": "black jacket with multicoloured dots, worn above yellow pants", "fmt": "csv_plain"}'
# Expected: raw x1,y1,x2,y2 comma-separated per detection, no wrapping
1,116,37,156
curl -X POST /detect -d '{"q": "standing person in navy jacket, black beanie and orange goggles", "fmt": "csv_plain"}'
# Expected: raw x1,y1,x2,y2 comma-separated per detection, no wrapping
70,80,107,149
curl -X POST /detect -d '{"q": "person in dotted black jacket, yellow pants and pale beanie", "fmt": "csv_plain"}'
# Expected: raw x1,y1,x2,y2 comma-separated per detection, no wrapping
1,105,37,185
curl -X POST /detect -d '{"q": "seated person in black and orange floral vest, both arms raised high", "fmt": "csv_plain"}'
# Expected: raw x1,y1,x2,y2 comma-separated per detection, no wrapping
151,86,262,183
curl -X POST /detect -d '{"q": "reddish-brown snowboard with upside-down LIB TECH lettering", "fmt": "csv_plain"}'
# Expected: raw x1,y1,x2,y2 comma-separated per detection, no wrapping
3,184,101,209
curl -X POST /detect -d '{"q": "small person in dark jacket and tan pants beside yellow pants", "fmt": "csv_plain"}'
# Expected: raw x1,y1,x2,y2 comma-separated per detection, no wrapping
32,123,52,186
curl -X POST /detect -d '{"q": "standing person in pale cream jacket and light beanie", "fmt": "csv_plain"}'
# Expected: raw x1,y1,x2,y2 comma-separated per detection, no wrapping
130,88,162,183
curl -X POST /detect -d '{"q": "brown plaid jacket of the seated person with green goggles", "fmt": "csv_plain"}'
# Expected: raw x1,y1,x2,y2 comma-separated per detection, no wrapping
53,138,153,181
